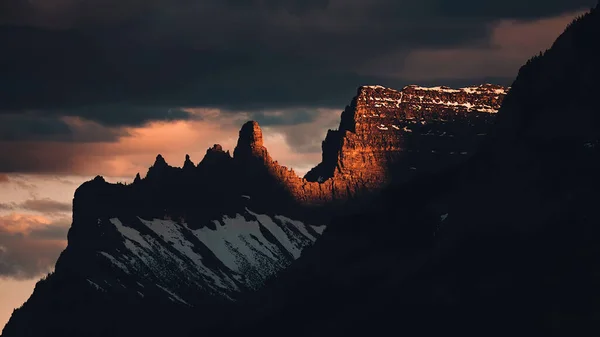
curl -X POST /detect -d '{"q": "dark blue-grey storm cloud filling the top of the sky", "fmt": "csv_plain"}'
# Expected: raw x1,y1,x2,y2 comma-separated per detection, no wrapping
0,0,595,127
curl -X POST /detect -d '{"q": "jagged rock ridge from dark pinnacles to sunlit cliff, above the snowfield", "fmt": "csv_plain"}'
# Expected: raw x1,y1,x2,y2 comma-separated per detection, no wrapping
111,84,509,213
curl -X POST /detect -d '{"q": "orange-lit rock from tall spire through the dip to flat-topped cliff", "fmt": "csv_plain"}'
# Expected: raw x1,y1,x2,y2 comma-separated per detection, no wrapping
243,84,508,205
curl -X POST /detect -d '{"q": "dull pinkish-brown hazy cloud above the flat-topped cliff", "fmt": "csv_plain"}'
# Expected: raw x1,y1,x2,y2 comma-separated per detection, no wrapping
366,12,584,82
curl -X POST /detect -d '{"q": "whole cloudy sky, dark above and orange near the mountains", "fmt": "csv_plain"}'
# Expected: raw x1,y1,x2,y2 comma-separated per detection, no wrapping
0,0,596,327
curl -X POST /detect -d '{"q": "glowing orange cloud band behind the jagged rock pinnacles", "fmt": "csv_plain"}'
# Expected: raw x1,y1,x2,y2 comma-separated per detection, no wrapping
0,108,341,181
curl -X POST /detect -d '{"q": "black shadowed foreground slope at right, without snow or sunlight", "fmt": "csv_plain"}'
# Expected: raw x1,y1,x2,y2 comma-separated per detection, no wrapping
219,6,600,337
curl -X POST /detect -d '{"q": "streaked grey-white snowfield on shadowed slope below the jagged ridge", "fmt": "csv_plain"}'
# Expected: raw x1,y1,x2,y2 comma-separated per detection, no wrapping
88,208,325,305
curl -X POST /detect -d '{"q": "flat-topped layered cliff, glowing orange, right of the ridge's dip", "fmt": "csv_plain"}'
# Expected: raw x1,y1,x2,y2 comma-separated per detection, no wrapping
307,85,507,181
